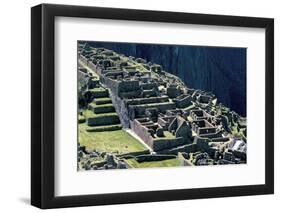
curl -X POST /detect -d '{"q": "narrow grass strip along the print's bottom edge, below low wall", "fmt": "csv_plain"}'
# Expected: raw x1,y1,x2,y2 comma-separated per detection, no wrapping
126,158,180,168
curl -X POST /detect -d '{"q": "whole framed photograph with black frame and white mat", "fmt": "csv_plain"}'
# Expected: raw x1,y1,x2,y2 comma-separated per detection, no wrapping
31,4,274,208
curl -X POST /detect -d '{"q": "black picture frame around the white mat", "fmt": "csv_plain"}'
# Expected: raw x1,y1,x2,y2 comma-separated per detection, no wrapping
31,4,274,209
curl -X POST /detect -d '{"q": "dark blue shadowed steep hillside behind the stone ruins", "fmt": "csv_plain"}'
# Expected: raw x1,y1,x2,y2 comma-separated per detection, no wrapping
86,42,246,116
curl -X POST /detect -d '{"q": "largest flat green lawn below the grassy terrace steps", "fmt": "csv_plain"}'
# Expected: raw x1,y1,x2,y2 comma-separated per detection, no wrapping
78,124,146,154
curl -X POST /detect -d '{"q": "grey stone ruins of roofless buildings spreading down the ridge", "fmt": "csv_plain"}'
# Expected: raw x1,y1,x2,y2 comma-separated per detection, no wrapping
78,43,247,168
